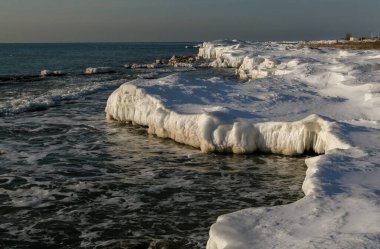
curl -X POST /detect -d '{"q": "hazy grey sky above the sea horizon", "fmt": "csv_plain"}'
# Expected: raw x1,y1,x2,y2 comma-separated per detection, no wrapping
0,0,380,43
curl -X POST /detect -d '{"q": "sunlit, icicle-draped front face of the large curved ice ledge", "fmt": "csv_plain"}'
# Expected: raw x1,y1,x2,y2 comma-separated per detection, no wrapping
105,76,348,155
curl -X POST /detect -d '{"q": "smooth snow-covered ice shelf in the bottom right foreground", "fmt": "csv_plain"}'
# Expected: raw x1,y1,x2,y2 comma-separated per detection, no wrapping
207,148,380,249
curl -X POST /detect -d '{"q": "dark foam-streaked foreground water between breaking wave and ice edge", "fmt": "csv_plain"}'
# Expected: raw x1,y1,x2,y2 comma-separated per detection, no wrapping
0,93,305,248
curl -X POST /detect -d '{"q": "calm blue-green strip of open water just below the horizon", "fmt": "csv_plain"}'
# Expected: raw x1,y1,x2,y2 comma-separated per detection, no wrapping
0,42,197,76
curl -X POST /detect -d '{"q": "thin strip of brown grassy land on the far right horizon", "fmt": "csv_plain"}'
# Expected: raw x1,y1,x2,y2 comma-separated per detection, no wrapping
300,40,380,50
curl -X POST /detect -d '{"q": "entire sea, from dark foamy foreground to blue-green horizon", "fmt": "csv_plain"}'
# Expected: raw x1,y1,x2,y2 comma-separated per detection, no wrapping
0,42,306,249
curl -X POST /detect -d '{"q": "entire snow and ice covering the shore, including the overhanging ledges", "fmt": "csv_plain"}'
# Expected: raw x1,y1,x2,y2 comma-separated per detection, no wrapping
106,41,380,249
